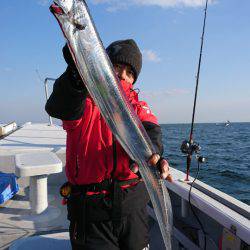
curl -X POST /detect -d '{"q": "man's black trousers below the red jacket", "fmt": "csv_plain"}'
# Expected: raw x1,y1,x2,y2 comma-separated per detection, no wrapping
67,184,149,250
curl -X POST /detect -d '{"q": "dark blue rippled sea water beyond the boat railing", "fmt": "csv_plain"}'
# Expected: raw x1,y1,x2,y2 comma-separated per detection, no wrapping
161,123,250,205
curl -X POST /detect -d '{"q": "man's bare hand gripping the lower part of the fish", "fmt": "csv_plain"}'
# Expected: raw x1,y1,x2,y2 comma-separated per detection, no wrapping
130,154,173,182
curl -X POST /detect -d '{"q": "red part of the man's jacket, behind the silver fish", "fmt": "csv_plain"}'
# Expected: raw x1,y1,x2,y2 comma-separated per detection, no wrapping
63,82,158,185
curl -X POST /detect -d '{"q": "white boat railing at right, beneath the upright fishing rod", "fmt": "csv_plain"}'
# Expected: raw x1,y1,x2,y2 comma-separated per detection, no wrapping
166,168,250,246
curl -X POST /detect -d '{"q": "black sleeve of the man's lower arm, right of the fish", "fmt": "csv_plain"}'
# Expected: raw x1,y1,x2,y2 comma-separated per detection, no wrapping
142,122,163,156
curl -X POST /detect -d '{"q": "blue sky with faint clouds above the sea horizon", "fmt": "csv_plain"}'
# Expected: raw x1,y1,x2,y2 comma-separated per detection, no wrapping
0,0,250,124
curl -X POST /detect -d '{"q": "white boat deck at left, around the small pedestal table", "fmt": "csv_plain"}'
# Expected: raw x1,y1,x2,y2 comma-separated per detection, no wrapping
0,123,167,250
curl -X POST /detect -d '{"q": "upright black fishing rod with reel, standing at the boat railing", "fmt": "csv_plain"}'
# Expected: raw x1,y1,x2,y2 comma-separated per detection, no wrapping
181,0,208,181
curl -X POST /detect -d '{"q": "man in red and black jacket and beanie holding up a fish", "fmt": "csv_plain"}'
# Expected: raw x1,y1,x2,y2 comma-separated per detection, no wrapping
46,39,172,250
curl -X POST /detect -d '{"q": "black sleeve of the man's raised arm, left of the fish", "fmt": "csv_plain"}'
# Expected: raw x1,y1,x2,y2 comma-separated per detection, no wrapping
45,69,87,121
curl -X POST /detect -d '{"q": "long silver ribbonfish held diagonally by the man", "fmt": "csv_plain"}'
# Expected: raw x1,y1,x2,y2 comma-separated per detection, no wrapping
50,0,172,249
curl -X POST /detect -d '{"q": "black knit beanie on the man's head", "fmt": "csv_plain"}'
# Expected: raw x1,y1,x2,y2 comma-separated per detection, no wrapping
106,39,142,82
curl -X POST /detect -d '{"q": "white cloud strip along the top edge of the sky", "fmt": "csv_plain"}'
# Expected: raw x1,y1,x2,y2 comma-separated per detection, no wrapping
92,0,215,11
